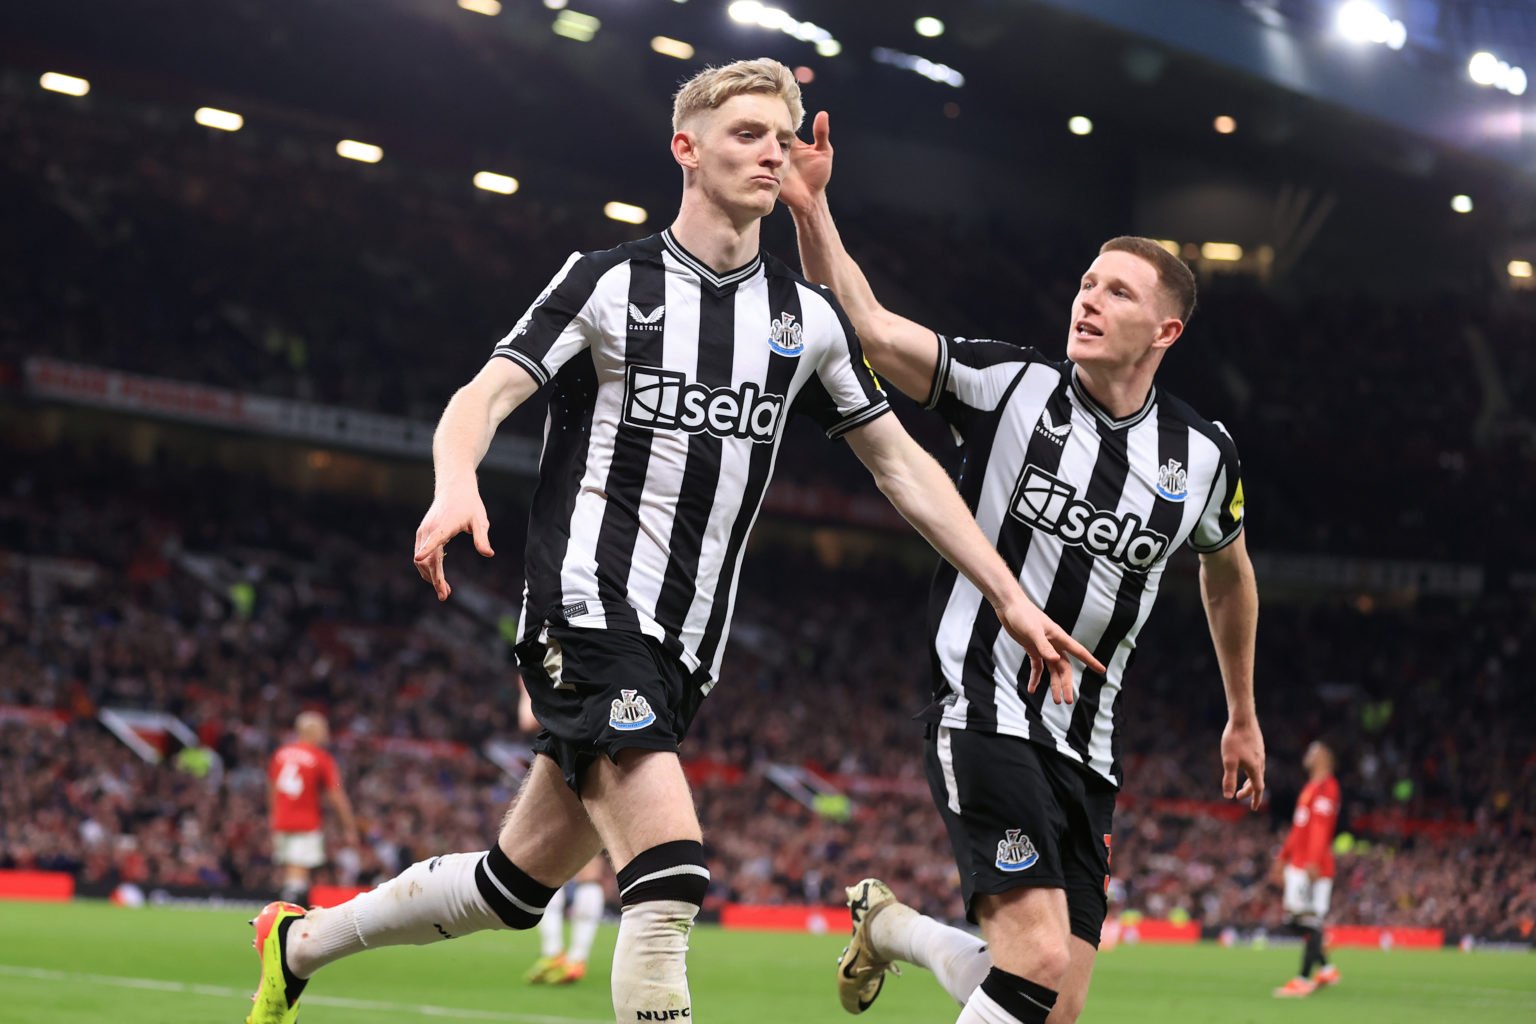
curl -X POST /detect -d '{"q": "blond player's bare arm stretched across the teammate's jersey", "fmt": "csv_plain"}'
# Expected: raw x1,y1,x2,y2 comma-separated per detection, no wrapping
845,415,1104,703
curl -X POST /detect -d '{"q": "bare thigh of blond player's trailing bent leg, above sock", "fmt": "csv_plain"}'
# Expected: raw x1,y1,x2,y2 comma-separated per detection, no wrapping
498,755,602,886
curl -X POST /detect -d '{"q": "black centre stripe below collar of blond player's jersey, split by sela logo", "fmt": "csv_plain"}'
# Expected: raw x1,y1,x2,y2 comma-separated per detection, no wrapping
656,280,737,654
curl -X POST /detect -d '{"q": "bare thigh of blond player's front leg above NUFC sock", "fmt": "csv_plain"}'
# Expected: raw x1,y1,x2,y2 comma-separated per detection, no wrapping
581,748,703,869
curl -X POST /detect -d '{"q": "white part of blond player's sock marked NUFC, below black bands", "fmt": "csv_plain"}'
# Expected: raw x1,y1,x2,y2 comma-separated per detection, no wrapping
613,900,699,1021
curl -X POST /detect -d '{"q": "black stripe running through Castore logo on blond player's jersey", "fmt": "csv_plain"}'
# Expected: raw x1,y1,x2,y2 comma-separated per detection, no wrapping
596,253,667,633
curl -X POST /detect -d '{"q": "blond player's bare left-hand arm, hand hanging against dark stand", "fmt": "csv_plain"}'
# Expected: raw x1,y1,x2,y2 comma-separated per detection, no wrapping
415,358,539,600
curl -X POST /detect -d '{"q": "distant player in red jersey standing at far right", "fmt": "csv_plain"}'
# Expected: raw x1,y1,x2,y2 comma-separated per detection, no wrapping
1272,740,1339,998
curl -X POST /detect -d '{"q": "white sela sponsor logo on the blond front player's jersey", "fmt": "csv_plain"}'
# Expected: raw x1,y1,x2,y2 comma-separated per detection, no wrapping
624,367,785,444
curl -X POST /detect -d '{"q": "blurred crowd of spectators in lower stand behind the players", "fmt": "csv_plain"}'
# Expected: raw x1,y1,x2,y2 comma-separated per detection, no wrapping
0,454,1536,938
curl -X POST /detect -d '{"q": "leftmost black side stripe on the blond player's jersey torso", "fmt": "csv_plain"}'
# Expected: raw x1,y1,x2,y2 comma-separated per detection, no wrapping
522,353,598,640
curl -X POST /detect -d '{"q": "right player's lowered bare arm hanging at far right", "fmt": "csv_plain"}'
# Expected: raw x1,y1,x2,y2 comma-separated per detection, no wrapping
1200,534,1264,811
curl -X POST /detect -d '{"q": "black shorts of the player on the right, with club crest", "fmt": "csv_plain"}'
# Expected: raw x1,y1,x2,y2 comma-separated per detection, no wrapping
923,725,1115,947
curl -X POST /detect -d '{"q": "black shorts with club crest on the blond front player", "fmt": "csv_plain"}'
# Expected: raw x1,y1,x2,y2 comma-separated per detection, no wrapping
516,626,705,792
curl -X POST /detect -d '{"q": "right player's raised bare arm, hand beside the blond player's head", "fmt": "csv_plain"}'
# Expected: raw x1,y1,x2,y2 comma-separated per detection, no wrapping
779,111,938,402
